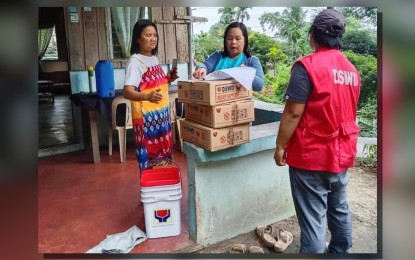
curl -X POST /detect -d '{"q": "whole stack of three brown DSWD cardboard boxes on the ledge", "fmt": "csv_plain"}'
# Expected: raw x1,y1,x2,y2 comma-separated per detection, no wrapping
177,80,255,152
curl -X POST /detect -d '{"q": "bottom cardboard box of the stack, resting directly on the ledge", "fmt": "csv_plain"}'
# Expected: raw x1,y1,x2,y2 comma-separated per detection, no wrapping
180,119,249,152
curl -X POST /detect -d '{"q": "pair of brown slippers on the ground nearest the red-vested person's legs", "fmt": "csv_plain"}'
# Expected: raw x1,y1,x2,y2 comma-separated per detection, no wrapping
256,225,293,253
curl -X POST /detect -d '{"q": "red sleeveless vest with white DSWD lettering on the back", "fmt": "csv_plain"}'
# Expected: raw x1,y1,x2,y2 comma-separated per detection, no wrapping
286,48,360,173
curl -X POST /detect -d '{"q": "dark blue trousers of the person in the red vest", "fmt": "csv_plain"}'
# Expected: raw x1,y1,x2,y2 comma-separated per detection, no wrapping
289,166,352,253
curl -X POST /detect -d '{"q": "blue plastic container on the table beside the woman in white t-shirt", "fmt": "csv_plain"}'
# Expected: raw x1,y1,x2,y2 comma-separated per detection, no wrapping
95,60,115,98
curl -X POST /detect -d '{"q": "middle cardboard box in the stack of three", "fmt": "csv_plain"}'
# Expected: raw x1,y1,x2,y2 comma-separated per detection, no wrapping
185,100,255,128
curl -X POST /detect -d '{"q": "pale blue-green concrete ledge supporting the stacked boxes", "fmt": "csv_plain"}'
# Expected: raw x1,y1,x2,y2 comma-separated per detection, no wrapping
183,118,295,246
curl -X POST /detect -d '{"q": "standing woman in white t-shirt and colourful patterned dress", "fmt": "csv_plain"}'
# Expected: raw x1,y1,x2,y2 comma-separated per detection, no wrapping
124,19,178,170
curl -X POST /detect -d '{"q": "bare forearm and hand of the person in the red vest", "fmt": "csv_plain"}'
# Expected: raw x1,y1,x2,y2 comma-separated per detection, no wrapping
274,100,305,166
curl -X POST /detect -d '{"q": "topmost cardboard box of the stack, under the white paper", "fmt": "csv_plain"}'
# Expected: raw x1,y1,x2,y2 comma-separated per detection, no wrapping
177,80,252,106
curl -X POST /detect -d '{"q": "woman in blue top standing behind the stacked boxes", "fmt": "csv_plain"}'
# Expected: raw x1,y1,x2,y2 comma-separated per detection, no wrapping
193,22,265,91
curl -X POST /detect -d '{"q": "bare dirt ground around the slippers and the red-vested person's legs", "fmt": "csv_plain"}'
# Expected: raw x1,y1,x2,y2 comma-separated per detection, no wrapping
193,167,377,254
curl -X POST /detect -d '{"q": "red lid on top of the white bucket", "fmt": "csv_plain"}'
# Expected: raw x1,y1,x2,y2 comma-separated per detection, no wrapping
140,167,180,187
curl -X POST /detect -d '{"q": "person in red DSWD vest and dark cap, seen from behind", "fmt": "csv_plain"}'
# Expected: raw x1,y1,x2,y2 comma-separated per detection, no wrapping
274,9,360,253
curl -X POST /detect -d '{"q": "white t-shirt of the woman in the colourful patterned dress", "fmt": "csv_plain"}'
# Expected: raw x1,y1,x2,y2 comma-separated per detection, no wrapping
124,54,159,89
